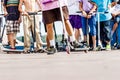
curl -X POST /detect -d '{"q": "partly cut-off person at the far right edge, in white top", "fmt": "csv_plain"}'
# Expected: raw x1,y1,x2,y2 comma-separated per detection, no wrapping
109,0,120,37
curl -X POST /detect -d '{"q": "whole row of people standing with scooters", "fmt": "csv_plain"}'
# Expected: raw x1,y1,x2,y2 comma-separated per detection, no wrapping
0,0,120,53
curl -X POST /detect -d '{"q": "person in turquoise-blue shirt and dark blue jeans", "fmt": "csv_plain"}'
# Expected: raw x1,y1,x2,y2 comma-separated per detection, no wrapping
92,0,112,50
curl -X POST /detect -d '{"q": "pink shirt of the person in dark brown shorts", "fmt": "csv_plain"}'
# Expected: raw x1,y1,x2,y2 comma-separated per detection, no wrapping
40,0,67,11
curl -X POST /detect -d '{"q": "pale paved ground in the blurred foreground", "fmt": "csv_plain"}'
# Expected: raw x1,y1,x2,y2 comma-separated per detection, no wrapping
0,51,120,80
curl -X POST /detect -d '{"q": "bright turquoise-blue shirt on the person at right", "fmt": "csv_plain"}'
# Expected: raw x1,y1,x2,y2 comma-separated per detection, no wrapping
92,0,112,21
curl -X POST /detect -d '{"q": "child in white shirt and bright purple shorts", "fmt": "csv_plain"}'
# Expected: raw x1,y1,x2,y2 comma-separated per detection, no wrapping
68,0,84,42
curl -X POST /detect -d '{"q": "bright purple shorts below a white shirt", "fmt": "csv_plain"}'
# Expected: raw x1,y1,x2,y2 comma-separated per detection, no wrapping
69,15,82,29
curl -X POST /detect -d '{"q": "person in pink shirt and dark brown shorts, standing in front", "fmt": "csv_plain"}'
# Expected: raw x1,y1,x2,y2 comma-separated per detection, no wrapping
39,0,79,54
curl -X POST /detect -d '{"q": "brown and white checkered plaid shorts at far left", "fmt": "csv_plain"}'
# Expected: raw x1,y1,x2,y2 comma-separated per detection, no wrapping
6,20,20,34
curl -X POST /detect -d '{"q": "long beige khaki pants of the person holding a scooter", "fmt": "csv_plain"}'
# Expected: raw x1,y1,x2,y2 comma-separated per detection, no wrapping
23,15,42,50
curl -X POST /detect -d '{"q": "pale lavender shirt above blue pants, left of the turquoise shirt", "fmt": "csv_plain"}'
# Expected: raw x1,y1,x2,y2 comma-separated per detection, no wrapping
79,0,93,12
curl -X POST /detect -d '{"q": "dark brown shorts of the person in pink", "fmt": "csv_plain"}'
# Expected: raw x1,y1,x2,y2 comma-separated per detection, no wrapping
42,6,69,24
